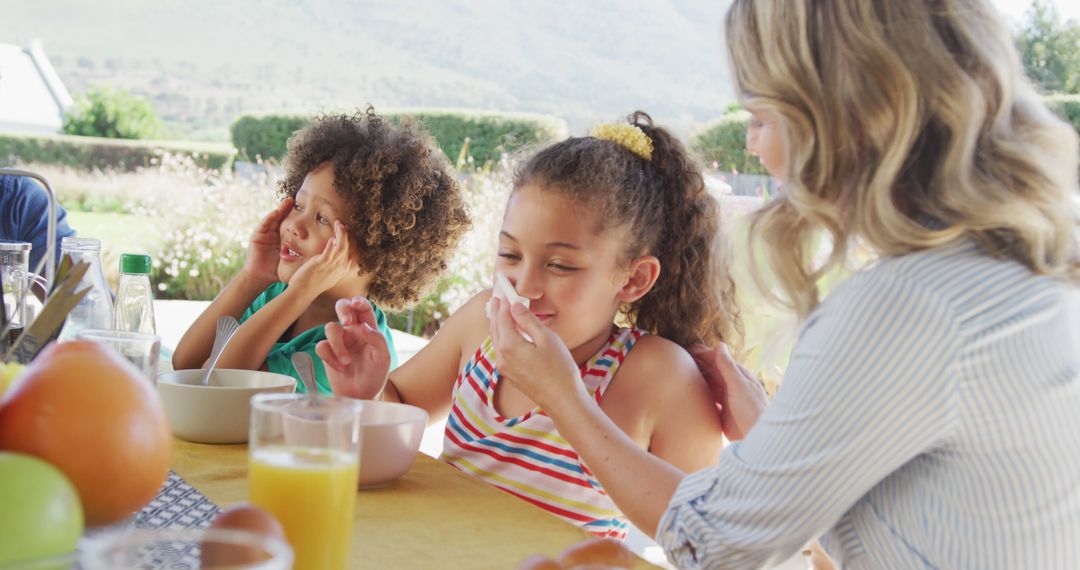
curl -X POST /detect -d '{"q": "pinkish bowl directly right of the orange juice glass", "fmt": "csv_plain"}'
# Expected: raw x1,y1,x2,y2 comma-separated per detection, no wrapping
360,401,428,489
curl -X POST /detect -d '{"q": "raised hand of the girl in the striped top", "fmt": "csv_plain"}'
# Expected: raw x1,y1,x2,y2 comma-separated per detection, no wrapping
315,297,390,399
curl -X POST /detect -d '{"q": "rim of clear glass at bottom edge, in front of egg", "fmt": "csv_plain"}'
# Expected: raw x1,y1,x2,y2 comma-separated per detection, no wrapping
79,529,291,570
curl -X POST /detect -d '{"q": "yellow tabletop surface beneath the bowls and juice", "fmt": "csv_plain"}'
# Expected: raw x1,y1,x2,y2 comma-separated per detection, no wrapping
172,439,657,570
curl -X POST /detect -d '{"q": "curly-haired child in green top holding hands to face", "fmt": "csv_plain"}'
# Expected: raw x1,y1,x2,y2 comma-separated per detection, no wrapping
173,108,470,393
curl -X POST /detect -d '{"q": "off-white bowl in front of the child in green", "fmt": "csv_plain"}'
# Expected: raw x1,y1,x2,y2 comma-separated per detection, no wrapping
158,368,296,444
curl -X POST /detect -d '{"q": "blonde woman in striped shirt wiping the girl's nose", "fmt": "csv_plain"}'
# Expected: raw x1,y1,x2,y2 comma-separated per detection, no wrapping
491,0,1080,569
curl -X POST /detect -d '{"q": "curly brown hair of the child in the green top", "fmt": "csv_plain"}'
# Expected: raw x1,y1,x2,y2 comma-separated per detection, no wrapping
279,107,471,309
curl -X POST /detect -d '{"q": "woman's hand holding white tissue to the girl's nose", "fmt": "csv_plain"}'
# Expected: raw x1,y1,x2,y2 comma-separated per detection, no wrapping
490,297,589,411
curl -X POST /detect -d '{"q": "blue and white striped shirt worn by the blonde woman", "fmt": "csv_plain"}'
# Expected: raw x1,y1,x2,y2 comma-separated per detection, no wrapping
657,241,1080,570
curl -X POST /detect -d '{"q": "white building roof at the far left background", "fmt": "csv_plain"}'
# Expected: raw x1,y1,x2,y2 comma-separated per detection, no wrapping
0,41,71,134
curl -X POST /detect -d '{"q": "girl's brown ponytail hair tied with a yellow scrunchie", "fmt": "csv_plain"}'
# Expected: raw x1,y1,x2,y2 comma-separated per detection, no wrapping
514,111,743,350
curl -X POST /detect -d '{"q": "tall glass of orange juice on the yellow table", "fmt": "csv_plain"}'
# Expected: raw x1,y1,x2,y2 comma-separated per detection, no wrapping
247,394,362,569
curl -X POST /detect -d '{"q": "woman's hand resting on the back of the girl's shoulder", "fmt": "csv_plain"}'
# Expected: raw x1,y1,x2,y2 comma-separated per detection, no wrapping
690,342,769,442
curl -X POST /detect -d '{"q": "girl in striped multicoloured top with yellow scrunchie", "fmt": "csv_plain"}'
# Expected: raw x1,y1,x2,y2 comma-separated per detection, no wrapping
318,112,738,538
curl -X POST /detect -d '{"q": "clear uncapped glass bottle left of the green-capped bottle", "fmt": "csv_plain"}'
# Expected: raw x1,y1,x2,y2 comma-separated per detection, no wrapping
60,238,112,340
